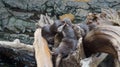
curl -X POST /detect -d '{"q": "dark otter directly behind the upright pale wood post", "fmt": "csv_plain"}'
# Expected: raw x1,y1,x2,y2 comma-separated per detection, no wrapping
42,20,63,48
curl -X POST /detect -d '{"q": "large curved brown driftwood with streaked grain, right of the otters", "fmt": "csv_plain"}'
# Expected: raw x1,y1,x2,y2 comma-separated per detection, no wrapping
83,8,120,67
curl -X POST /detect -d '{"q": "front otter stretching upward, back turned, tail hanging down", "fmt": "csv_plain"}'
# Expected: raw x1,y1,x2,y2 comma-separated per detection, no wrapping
53,20,77,67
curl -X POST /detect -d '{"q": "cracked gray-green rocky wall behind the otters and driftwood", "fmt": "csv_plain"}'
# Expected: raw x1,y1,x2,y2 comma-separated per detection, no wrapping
0,0,120,44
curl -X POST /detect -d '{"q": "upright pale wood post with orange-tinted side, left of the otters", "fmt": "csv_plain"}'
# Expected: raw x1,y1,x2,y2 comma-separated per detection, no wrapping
33,28,53,67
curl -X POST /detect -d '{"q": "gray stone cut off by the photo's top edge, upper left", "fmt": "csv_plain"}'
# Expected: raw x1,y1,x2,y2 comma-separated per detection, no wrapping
4,0,47,10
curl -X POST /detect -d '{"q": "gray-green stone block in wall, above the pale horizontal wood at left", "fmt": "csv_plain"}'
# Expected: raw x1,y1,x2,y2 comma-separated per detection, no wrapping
2,17,35,33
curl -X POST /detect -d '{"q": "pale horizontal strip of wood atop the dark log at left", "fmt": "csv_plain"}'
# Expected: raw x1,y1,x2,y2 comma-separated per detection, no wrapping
0,39,34,54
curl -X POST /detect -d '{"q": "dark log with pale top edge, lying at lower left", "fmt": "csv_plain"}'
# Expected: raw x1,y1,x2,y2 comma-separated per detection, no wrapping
0,39,36,67
